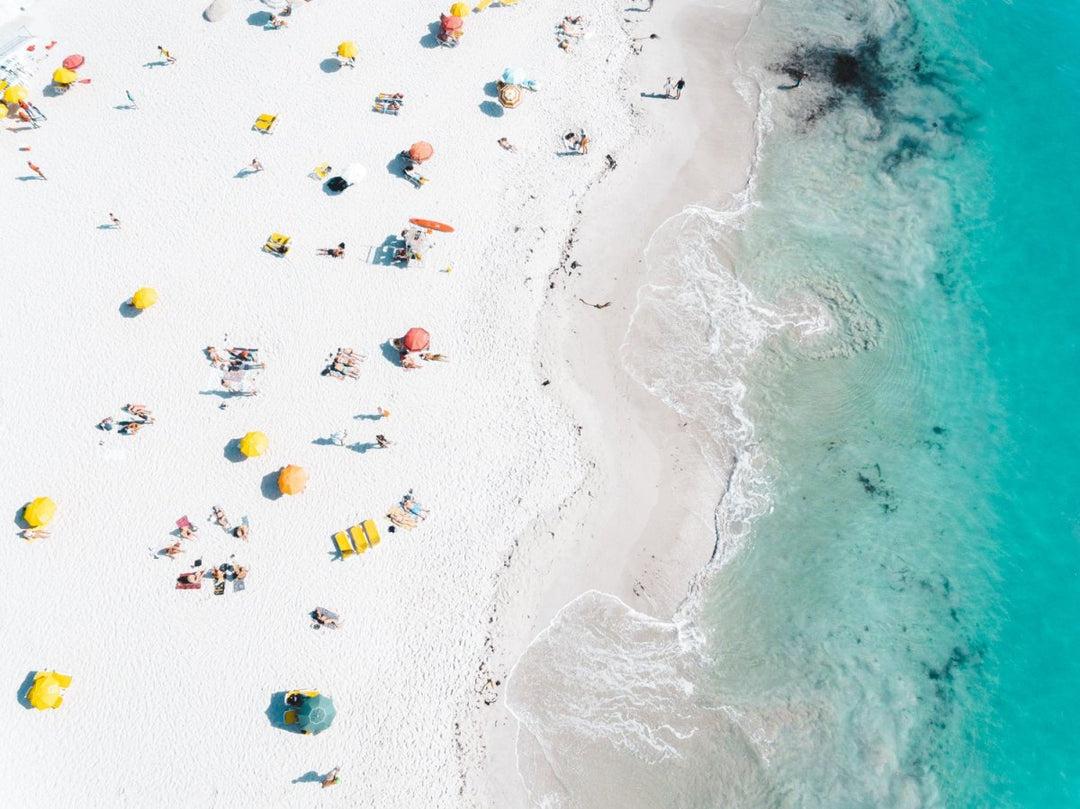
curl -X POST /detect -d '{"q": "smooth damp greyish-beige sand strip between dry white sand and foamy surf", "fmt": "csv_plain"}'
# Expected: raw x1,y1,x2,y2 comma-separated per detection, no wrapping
483,5,757,807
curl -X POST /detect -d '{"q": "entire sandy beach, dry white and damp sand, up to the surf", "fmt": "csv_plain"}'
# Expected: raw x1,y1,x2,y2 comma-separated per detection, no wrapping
0,0,754,807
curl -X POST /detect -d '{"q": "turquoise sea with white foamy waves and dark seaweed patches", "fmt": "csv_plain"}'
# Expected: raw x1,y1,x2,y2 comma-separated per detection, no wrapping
508,0,1080,808
